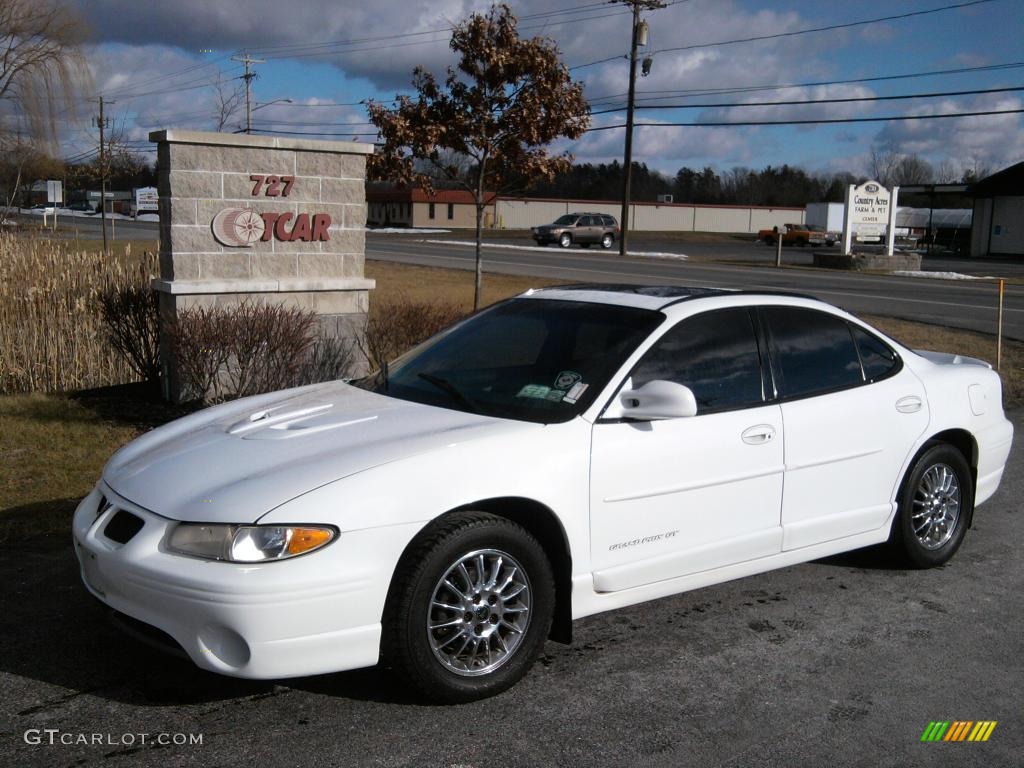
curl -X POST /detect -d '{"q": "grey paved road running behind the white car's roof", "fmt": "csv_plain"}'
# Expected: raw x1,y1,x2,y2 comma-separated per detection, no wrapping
367,234,1024,339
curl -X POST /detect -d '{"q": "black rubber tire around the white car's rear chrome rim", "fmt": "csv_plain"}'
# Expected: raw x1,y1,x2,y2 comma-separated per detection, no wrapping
889,442,974,568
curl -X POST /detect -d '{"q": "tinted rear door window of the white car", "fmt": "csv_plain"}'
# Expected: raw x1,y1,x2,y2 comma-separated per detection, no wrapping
762,307,864,397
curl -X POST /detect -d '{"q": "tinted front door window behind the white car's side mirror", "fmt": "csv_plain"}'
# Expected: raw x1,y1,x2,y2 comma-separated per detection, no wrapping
633,308,763,414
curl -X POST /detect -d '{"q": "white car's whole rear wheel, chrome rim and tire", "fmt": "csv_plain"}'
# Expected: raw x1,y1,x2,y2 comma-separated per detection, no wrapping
891,442,974,568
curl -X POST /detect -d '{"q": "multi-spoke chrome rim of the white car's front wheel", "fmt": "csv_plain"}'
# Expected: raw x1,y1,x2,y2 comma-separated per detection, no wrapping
427,549,530,677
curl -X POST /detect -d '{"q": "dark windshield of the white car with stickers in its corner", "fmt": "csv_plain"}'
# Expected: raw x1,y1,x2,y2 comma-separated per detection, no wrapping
353,299,665,424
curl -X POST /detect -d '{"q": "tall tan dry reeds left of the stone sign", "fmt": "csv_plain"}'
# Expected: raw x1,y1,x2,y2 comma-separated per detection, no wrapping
0,233,157,393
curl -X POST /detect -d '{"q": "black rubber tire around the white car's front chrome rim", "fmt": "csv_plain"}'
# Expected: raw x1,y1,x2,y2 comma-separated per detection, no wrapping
381,512,555,703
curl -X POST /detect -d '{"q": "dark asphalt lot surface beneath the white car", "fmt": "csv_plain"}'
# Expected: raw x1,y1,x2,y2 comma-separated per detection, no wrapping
0,412,1024,768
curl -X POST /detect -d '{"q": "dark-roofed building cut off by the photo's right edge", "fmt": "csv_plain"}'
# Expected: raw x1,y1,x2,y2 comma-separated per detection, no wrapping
969,163,1024,256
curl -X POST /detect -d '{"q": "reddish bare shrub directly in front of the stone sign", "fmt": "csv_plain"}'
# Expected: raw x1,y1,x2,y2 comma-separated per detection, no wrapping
167,302,315,402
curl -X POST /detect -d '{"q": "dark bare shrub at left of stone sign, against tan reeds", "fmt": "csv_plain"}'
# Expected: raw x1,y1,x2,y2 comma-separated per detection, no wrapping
99,285,160,381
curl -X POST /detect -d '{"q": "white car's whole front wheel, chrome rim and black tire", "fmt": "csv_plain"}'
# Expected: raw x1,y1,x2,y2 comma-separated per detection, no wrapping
382,512,555,703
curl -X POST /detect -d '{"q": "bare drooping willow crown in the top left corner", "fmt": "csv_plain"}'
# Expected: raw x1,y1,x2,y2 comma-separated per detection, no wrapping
0,0,89,145
